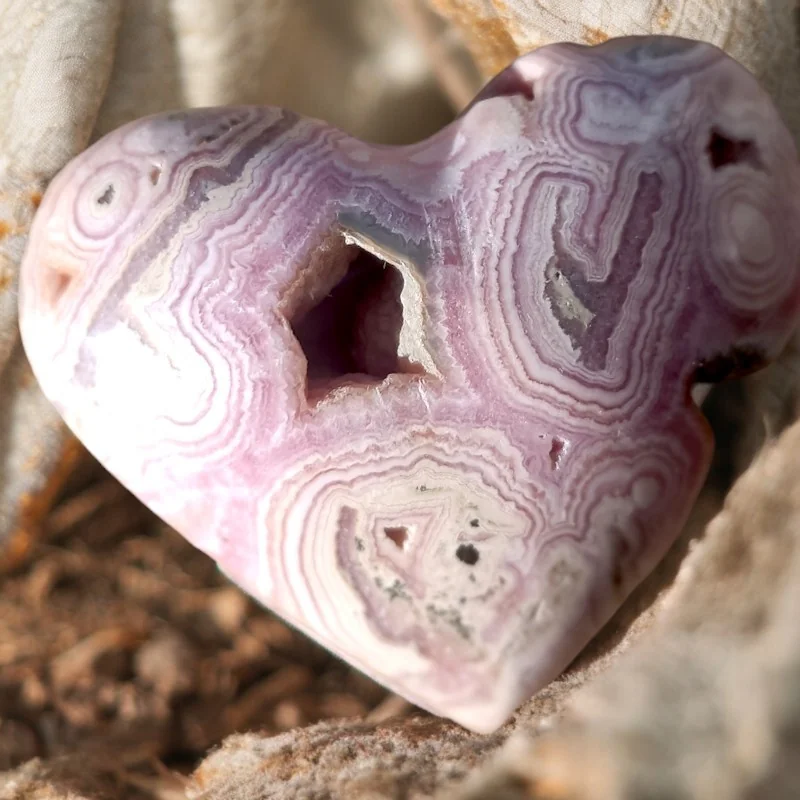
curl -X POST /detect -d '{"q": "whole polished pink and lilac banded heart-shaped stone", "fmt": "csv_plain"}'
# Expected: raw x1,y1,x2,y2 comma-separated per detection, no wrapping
21,39,800,731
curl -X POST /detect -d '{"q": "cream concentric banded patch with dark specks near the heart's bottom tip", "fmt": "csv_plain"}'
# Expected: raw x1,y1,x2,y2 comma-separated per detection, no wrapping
260,427,545,648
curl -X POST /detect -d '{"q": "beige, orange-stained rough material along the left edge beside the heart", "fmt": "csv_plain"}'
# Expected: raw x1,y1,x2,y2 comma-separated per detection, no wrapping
0,0,121,556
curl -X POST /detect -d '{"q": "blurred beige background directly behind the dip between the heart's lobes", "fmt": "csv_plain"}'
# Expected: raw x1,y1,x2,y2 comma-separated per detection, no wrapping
171,0,451,143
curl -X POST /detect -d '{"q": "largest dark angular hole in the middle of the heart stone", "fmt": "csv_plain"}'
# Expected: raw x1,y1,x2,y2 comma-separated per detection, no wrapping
289,234,432,405
